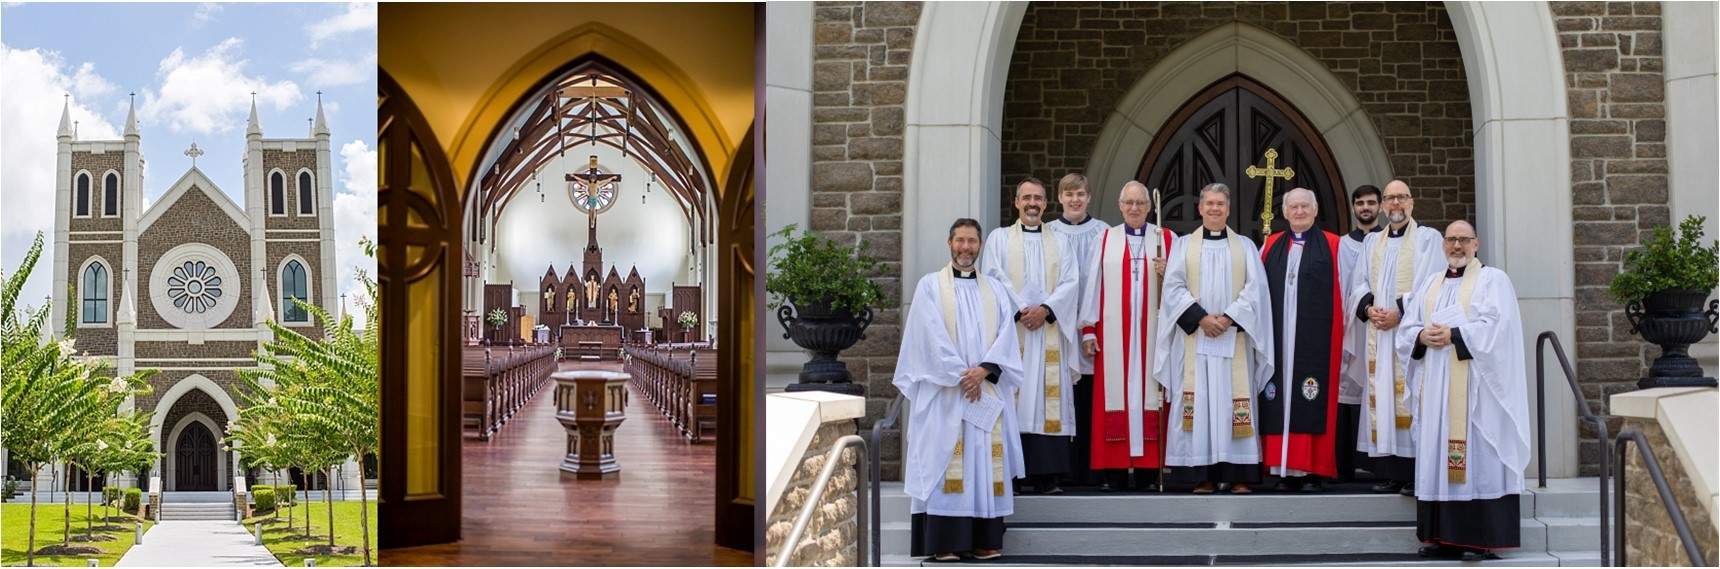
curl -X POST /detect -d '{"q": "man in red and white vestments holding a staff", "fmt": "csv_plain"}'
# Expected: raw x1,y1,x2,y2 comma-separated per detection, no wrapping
1080,180,1175,492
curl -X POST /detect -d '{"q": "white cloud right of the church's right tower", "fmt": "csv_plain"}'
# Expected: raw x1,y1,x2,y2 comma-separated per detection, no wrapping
334,139,377,309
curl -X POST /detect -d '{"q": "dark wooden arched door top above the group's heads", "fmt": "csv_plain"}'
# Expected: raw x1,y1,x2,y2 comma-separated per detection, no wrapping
1135,74,1350,242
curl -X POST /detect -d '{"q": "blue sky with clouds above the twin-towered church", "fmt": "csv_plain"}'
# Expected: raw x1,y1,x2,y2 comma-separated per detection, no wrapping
0,2,377,316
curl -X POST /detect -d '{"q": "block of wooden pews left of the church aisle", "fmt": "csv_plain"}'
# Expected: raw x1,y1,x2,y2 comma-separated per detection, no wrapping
461,346,556,440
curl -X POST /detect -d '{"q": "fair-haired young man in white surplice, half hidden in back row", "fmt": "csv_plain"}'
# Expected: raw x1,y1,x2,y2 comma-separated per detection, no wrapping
1046,172,1106,486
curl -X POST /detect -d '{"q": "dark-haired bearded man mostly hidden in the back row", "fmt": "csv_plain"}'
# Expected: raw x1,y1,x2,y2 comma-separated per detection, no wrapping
1336,186,1383,481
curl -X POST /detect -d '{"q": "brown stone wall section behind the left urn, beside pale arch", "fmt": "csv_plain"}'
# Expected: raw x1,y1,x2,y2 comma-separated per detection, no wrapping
808,2,920,480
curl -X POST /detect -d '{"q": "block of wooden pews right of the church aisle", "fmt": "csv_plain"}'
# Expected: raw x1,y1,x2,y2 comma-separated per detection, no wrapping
626,344,717,442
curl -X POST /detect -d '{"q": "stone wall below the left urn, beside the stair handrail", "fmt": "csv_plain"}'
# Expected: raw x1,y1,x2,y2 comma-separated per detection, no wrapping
765,421,863,567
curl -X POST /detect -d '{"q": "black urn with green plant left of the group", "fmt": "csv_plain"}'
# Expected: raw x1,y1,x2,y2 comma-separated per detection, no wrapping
764,225,884,395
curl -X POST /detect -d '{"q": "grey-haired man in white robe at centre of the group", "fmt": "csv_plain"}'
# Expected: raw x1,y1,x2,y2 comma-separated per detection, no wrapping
1152,184,1275,493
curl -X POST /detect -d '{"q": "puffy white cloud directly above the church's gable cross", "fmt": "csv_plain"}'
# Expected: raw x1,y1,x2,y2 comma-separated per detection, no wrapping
139,38,303,134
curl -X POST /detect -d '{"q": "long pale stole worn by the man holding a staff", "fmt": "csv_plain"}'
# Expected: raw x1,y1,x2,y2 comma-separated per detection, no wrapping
1099,227,1164,433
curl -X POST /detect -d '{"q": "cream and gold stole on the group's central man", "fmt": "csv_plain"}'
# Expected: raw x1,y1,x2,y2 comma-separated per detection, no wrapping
1182,227,1254,438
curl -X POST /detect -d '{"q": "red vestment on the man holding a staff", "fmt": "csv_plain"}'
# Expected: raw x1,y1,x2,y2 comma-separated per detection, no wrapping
1082,229,1173,469
